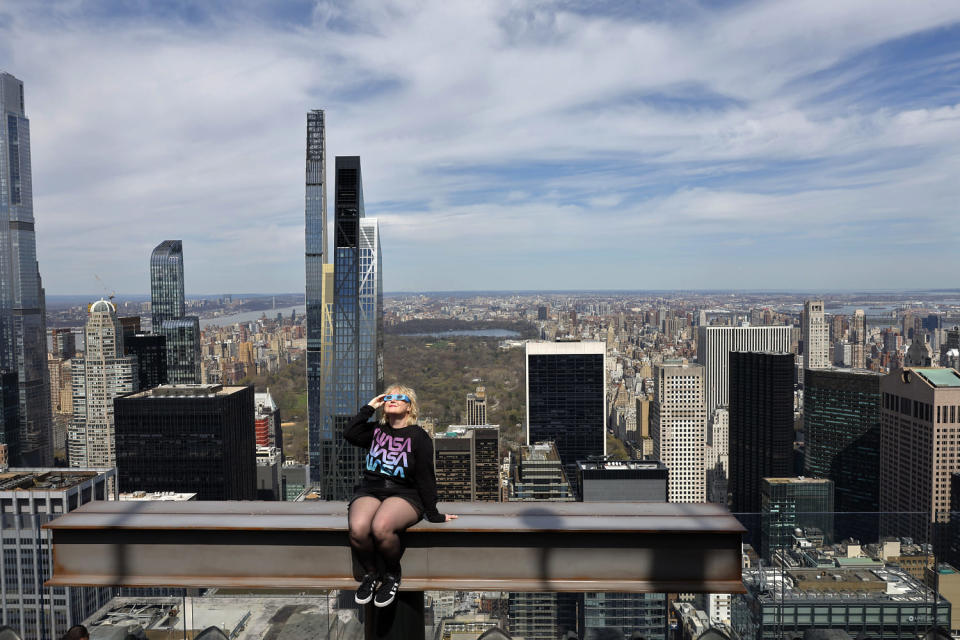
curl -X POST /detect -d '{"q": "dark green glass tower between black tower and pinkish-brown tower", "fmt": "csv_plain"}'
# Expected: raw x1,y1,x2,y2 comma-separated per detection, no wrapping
803,369,882,541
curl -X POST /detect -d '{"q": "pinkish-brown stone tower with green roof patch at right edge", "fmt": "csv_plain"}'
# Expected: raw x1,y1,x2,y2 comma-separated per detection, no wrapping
880,368,960,542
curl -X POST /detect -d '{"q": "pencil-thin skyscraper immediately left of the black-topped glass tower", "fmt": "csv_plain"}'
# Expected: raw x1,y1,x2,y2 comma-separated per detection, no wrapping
304,109,333,490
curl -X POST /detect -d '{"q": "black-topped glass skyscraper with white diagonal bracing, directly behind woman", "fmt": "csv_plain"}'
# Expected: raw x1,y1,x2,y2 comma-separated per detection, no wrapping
318,156,383,500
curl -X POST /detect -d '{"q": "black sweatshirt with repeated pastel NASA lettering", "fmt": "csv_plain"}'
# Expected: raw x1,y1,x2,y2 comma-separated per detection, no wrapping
343,404,446,522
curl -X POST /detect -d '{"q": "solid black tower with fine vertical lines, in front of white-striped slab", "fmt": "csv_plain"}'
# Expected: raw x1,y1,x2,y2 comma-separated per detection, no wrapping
730,352,794,513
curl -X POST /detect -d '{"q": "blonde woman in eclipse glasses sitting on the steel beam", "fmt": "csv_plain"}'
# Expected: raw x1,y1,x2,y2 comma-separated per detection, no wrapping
343,384,457,607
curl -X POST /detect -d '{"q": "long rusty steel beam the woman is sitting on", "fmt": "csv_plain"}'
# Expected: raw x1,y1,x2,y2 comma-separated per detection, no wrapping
44,501,744,593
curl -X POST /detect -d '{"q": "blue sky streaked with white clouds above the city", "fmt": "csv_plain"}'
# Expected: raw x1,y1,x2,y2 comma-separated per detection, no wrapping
0,0,960,295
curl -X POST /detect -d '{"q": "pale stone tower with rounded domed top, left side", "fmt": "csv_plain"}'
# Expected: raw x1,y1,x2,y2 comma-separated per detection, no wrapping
67,300,138,467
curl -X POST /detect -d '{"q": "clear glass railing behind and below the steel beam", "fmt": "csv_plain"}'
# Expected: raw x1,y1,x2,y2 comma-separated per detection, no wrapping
7,505,960,640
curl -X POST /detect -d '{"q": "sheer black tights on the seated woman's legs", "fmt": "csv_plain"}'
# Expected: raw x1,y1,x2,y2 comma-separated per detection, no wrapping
348,496,420,576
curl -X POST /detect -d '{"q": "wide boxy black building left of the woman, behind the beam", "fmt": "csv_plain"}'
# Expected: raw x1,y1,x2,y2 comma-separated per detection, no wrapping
114,385,257,500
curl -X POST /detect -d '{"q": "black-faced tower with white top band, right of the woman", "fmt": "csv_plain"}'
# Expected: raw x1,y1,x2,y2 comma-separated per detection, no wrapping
526,342,607,490
